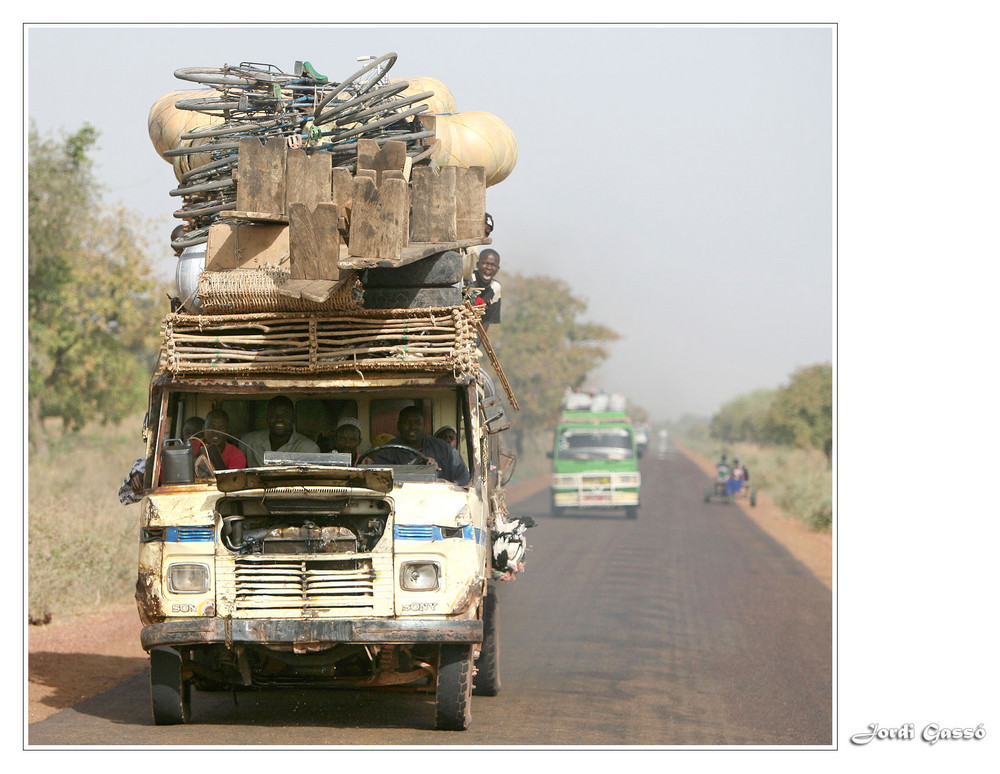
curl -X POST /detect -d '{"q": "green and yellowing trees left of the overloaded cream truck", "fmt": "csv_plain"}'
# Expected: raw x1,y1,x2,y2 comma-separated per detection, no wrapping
27,125,165,448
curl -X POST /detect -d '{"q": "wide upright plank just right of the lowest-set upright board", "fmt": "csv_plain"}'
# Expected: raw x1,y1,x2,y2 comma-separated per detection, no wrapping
348,175,410,260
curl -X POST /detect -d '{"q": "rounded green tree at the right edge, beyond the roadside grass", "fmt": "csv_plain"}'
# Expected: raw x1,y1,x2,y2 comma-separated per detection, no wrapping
768,363,833,461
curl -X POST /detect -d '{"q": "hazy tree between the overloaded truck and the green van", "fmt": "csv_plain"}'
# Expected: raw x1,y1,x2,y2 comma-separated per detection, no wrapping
489,273,618,429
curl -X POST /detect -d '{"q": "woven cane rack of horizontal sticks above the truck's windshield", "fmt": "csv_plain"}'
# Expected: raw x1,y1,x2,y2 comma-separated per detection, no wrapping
161,305,479,375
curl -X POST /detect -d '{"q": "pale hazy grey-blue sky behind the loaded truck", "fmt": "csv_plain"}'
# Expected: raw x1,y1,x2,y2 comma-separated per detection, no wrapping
27,26,835,419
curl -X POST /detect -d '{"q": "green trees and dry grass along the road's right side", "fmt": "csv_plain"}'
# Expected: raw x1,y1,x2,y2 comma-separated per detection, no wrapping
674,363,833,532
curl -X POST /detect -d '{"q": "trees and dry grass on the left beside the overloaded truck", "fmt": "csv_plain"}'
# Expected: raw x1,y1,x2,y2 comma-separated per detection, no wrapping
26,125,168,623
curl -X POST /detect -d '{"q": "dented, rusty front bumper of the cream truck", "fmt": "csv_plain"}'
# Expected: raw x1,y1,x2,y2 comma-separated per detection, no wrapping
142,618,483,651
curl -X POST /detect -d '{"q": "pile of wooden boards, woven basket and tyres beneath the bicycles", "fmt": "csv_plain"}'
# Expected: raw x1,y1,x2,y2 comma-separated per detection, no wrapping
198,138,490,314
